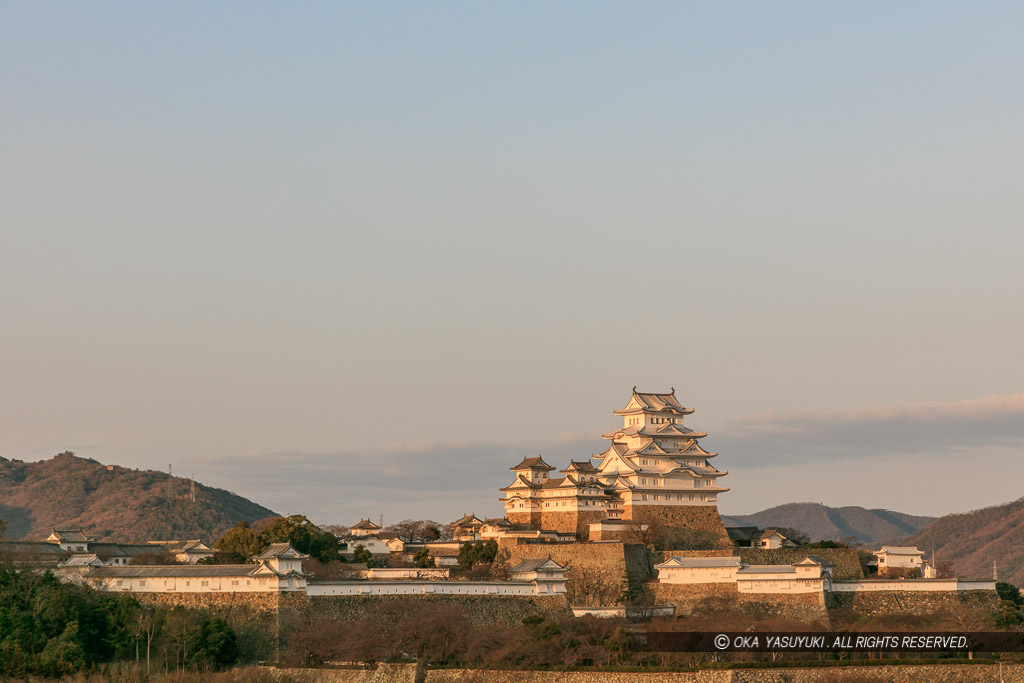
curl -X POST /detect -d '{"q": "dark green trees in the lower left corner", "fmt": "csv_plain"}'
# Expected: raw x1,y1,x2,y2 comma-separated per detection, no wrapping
0,567,238,678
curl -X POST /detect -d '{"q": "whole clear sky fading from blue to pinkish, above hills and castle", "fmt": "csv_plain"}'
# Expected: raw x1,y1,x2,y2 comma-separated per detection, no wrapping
0,0,1024,523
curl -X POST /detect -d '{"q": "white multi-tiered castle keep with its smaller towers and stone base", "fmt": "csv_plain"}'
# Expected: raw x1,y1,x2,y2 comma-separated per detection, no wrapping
501,387,729,541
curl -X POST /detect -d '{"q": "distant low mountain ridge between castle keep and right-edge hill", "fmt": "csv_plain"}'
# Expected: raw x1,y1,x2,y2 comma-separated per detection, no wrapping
722,503,935,546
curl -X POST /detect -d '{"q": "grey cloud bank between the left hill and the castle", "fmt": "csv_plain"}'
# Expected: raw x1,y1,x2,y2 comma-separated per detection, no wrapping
182,434,601,523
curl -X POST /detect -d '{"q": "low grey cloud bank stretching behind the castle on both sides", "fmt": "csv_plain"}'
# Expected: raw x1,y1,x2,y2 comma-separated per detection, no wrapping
176,393,1024,523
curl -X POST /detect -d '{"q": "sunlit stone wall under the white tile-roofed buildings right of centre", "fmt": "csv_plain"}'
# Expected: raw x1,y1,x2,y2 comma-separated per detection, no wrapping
650,582,828,625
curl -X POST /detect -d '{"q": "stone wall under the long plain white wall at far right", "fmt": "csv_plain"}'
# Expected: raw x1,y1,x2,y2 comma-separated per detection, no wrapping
828,591,999,616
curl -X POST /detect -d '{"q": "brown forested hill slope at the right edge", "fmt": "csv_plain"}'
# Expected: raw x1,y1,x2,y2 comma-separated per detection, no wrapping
906,498,1024,586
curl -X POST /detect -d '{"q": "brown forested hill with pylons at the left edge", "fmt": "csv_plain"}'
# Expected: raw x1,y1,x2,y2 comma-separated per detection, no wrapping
0,453,275,542
